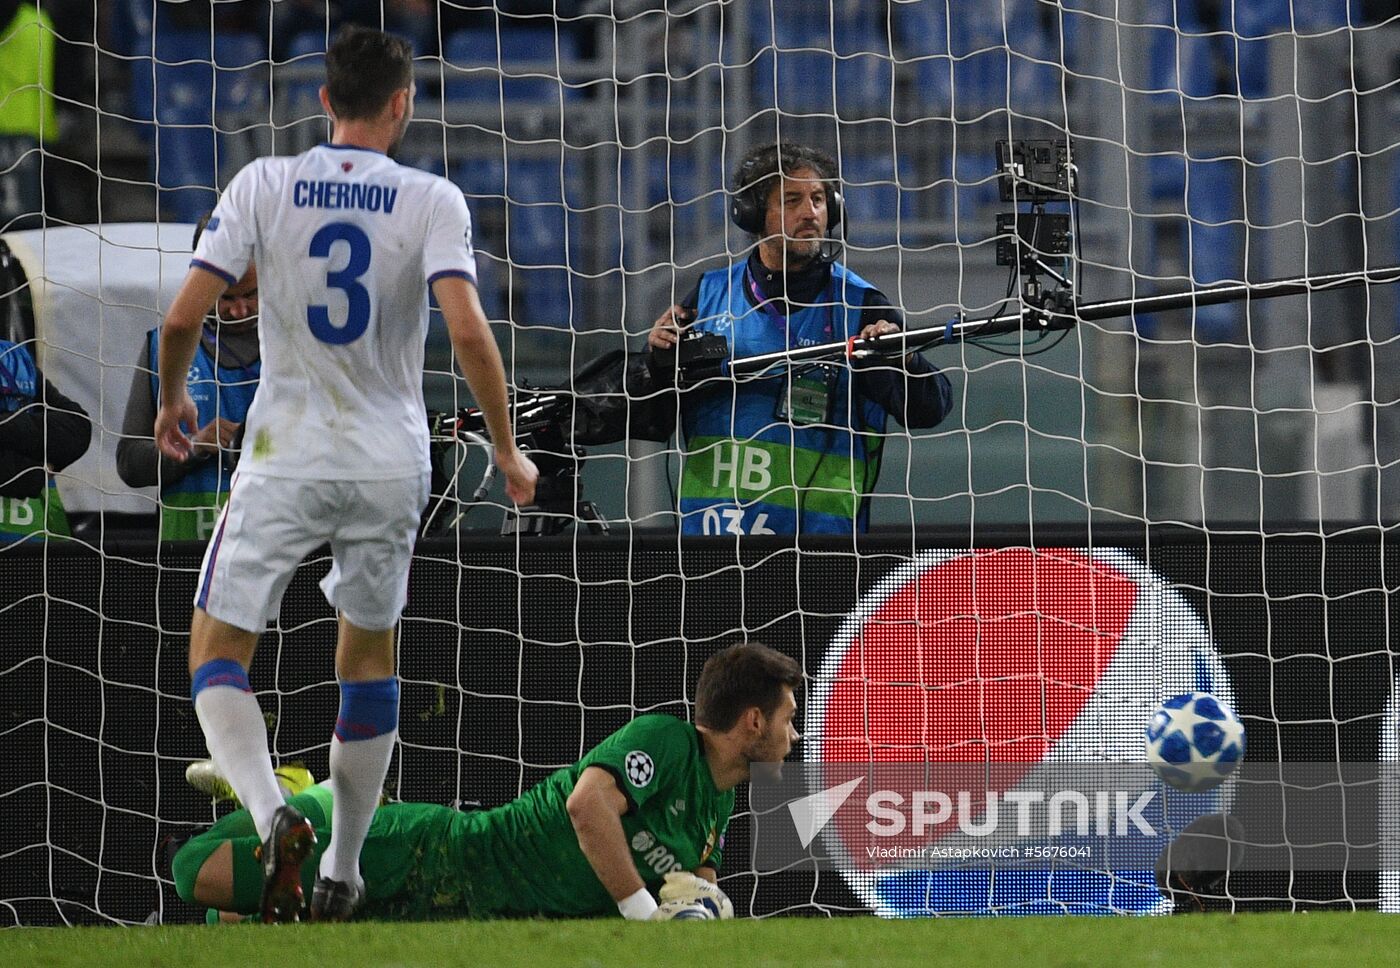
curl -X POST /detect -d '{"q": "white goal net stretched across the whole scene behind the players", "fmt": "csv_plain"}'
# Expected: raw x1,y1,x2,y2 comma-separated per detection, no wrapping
0,0,1400,925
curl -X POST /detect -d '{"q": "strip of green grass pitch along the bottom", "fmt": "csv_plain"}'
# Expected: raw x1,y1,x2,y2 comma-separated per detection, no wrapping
0,913,1383,968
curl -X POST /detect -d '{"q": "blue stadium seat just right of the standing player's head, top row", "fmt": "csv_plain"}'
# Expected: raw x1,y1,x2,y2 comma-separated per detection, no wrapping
442,27,580,104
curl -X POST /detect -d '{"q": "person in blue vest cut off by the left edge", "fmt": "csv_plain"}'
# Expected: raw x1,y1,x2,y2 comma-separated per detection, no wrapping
0,339,92,545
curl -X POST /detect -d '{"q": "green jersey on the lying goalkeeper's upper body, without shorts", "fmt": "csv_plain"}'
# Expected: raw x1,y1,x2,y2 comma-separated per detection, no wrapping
451,714,734,916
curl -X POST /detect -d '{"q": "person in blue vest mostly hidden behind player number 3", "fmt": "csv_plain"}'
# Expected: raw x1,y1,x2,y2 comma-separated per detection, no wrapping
116,214,262,541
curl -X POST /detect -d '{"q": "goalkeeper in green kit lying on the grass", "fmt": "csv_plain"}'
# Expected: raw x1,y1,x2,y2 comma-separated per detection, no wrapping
172,643,802,920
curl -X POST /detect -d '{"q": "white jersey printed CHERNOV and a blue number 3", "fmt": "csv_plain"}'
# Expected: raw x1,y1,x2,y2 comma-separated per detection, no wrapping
193,144,476,480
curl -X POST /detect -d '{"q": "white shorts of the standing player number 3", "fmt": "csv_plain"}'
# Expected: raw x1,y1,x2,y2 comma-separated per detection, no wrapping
195,471,428,632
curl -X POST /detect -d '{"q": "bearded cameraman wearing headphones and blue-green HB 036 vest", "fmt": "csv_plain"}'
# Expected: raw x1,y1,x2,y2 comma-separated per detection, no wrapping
647,143,952,535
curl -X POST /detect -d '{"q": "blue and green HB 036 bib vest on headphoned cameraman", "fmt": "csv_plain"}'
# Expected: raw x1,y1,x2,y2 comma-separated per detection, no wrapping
680,262,886,535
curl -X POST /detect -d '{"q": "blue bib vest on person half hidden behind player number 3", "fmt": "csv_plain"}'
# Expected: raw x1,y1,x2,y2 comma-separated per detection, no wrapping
147,329,262,541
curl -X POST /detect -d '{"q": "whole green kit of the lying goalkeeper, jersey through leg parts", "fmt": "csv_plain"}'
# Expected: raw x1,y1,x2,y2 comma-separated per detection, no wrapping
174,716,734,920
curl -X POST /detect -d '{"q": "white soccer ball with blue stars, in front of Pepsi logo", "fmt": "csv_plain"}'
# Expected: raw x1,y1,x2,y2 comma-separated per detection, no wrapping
1142,692,1245,793
